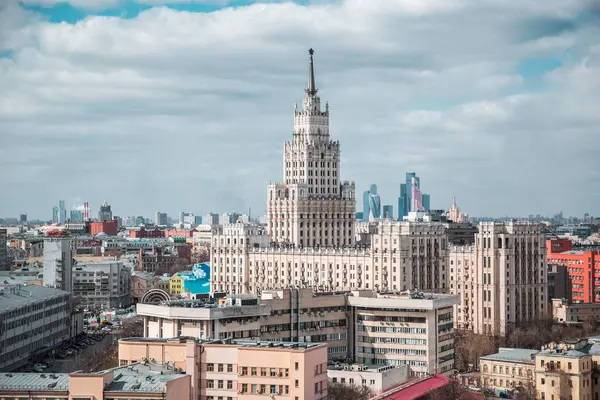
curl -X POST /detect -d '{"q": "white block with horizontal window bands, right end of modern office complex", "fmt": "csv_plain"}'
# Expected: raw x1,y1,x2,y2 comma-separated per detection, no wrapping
348,292,458,376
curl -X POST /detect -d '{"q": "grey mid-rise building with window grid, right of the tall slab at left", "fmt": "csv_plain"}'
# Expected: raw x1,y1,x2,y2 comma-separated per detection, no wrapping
72,260,132,310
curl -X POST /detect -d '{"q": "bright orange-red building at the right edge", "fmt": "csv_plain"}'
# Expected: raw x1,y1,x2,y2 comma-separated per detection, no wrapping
546,239,600,303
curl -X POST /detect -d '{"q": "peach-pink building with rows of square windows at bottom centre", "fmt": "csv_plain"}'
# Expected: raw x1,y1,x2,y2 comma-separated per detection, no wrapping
119,338,327,400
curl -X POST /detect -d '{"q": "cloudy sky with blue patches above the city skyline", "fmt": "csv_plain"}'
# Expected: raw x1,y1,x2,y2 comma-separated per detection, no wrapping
0,0,600,219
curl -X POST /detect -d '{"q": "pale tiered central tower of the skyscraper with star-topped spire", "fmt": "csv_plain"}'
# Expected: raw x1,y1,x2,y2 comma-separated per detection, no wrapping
267,49,356,247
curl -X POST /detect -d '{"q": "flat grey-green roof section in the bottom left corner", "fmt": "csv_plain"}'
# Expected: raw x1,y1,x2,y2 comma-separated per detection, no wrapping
0,372,69,392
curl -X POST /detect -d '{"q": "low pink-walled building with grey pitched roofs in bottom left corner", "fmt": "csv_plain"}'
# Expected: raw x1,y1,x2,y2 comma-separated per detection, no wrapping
0,362,190,400
